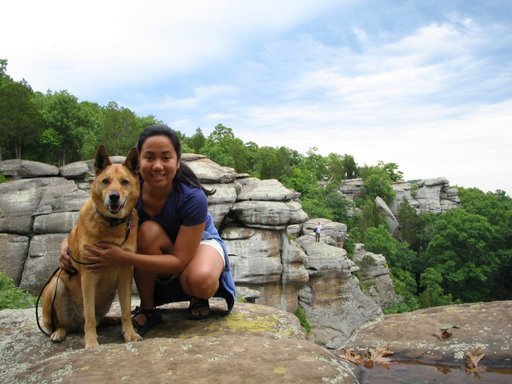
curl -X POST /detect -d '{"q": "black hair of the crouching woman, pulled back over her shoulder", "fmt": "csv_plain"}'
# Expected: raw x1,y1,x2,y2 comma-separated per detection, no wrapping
137,125,215,196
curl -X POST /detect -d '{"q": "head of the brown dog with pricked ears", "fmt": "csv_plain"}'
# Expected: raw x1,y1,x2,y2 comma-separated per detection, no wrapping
91,145,139,218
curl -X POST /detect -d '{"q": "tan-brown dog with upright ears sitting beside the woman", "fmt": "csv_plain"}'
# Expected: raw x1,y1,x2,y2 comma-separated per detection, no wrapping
42,145,141,348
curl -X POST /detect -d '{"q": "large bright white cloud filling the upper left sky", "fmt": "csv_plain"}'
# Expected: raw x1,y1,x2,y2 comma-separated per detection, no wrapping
0,0,344,96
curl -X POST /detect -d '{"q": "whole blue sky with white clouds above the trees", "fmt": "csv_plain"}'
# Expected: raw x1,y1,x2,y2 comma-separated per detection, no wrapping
0,0,512,196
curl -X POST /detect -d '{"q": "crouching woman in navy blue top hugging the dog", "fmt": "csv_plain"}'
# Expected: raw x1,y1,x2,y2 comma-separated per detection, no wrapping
60,125,235,336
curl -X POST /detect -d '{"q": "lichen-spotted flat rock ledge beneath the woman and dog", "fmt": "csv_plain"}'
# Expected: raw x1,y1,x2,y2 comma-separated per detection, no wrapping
0,301,360,384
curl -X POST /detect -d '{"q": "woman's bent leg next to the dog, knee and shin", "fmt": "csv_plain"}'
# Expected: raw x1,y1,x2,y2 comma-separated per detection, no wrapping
133,221,172,321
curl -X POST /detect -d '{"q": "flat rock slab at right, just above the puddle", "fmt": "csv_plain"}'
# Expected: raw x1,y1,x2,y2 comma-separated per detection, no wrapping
344,301,512,368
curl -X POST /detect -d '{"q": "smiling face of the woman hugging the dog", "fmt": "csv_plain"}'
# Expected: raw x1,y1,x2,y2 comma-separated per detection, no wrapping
140,135,180,188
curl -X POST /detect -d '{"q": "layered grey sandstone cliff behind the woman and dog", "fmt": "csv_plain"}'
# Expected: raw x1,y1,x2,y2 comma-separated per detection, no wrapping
0,154,392,348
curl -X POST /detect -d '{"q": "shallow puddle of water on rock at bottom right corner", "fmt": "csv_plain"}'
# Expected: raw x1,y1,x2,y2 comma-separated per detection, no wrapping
360,362,512,384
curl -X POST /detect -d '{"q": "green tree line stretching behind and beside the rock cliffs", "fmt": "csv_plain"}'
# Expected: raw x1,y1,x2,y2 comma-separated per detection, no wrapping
0,60,512,312
